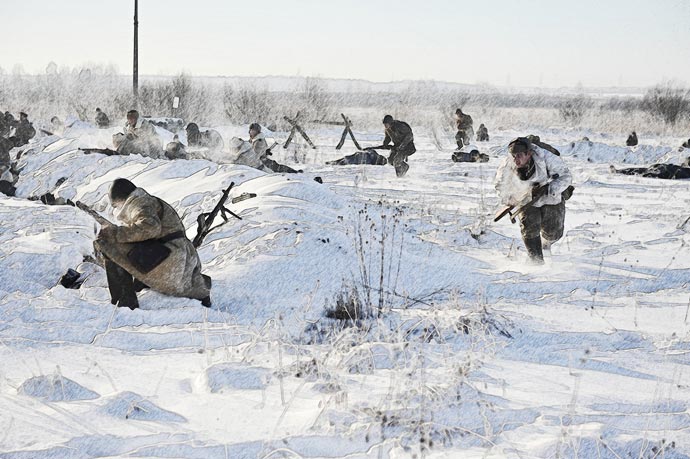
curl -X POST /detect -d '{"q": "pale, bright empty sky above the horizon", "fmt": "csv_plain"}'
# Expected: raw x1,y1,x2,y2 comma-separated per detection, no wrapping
0,0,690,87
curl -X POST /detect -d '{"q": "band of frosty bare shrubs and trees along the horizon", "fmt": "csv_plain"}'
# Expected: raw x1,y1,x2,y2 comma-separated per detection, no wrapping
0,66,690,135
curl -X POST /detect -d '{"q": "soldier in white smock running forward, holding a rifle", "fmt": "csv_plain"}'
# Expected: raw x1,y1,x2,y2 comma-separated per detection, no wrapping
496,137,572,264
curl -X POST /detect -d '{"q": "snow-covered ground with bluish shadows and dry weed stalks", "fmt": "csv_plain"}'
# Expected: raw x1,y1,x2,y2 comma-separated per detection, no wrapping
0,126,690,459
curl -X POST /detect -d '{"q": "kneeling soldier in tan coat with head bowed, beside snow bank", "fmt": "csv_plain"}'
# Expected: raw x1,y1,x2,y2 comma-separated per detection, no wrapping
94,178,211,309
